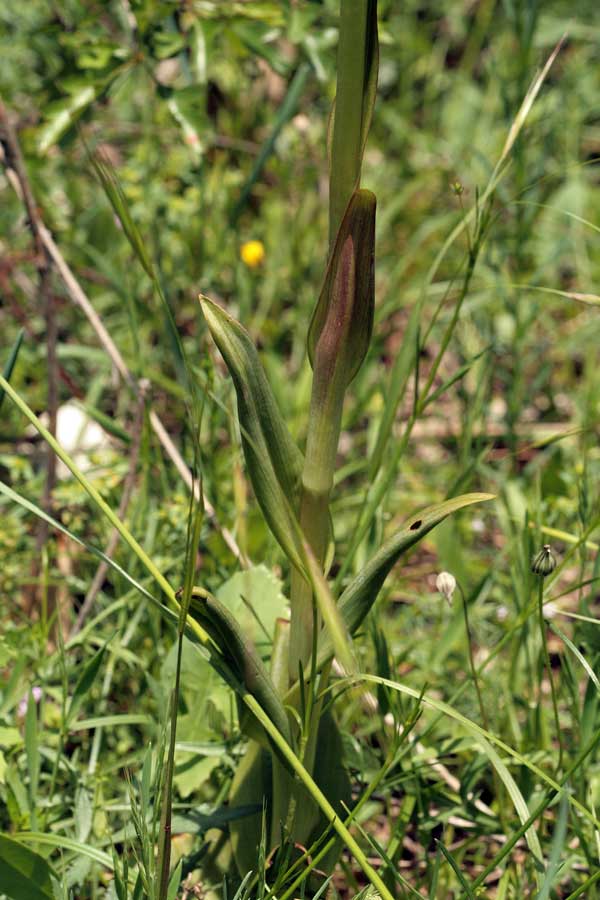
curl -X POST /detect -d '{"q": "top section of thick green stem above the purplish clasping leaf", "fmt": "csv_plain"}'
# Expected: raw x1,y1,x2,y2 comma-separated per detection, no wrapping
329,0,369,250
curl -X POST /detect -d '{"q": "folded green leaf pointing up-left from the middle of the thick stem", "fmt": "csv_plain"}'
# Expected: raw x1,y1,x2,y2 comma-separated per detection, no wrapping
200,296,303,569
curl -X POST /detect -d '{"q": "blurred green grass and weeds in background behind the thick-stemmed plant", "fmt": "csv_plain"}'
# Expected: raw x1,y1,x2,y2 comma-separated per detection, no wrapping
0,0,600,897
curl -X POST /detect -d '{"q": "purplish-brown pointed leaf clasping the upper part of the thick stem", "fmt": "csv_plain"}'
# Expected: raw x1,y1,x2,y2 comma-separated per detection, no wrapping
308,190,376,391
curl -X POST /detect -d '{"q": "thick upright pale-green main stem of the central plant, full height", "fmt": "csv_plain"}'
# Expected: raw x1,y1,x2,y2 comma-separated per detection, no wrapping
289,0,377,679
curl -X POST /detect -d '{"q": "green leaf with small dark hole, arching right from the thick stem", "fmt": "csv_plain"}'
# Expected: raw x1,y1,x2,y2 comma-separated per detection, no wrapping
308,493,495,668
